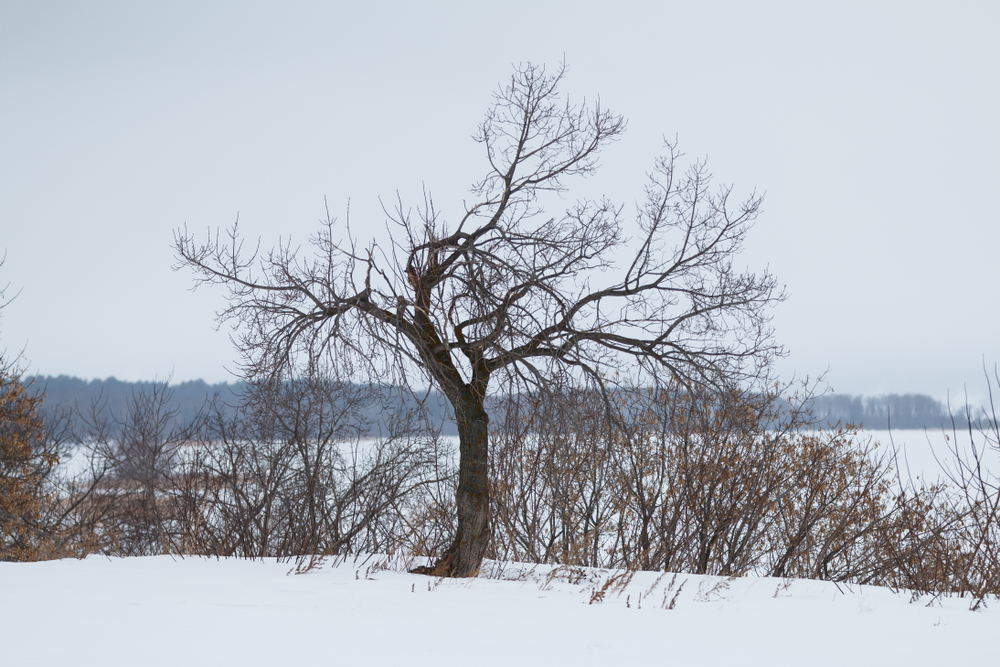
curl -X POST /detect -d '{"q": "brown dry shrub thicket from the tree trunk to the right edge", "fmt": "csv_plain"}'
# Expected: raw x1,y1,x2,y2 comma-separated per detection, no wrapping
491,378,1000,599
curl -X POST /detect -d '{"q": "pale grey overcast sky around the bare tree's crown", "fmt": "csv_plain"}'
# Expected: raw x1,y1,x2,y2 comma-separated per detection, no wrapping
0,0,1000,397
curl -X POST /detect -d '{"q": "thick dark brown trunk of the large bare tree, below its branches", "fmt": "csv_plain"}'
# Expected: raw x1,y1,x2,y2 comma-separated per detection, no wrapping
413,392,490,577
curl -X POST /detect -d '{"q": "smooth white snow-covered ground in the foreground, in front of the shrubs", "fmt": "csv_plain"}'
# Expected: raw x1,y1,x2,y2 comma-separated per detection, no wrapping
0,556,1000,667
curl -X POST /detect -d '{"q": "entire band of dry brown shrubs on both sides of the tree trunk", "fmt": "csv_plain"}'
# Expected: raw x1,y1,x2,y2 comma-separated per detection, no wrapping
11,360,1000,608
